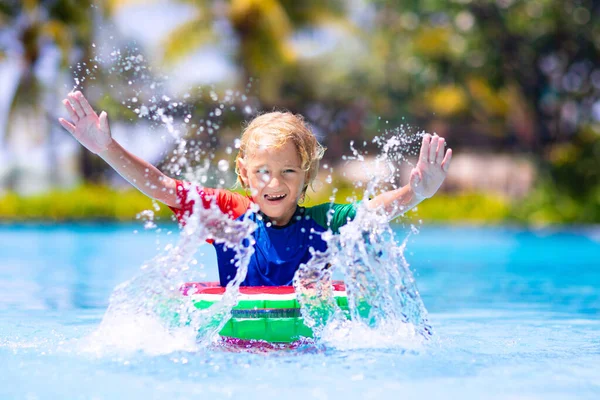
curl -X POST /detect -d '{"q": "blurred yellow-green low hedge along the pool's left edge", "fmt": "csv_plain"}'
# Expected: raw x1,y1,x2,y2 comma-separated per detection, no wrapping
0,185,172,222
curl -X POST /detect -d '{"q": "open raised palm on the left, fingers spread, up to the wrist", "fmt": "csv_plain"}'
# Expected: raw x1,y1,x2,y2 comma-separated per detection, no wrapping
58,91,113,154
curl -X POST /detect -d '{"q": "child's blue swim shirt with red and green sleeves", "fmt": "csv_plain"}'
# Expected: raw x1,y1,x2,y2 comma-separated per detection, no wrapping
171,181,356,286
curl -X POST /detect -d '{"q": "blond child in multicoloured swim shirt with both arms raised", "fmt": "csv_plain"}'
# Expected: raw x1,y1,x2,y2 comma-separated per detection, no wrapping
59,92,452,286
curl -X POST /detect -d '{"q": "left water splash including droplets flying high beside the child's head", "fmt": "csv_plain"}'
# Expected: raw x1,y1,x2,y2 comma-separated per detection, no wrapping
73,36,255,354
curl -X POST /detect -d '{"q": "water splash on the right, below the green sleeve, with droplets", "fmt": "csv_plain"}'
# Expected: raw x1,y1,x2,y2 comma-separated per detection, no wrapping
294,129,432,348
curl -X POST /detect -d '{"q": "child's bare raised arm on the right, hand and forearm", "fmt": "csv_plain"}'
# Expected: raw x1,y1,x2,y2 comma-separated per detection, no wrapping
367,134,452,220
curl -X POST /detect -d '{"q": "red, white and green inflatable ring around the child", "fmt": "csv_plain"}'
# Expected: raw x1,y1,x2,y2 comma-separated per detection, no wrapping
181,281,348,343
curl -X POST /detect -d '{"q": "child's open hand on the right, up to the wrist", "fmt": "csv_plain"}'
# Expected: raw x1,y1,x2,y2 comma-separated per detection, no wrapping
409,134,452,199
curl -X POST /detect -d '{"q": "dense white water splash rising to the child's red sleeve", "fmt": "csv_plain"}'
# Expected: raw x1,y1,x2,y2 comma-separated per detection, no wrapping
83,191,255,354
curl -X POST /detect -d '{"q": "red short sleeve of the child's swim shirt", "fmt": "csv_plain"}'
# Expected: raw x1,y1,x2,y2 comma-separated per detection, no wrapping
169,180,251,224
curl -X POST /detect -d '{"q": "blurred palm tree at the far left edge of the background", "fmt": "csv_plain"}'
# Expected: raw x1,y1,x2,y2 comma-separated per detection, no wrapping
0,0,101,189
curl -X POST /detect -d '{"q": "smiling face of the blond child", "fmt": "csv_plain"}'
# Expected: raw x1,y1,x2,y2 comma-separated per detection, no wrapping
240,141,306,225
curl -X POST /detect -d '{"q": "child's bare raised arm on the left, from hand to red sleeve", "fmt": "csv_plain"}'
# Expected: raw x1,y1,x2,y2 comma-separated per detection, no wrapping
58,91,180,208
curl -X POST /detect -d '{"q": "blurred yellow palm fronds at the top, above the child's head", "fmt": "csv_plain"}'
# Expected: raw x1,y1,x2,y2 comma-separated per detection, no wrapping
164,0,351,104
